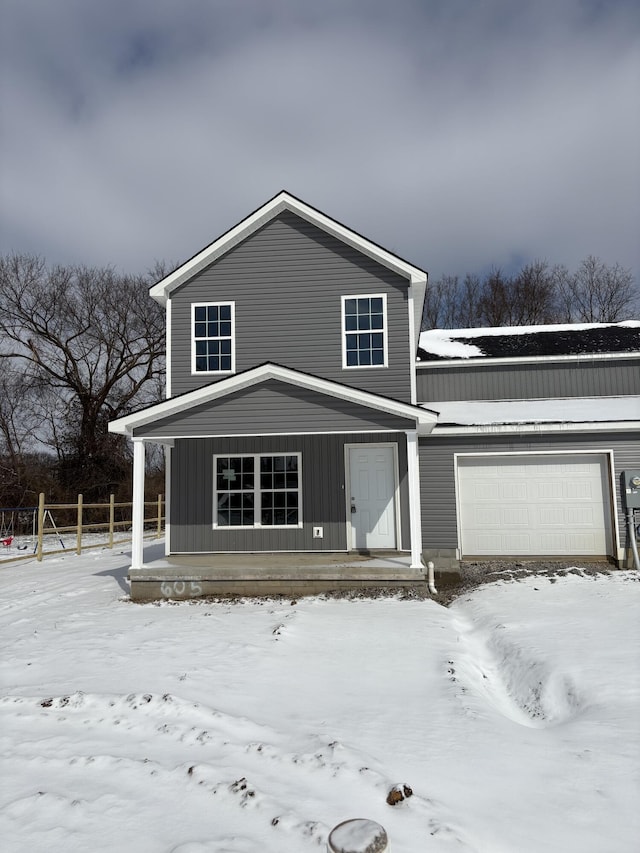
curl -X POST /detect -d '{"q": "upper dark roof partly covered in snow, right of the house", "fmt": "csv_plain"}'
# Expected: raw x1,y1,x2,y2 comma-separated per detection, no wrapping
418,320,640,362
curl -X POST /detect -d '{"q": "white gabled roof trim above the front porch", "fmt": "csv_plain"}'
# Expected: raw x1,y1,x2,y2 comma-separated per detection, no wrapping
109,362,438,436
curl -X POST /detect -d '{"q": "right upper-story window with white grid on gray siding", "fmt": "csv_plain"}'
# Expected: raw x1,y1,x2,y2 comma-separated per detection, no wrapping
342,293,387,367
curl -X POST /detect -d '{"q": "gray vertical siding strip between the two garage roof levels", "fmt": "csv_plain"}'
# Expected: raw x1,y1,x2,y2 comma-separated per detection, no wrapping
417,357,640,403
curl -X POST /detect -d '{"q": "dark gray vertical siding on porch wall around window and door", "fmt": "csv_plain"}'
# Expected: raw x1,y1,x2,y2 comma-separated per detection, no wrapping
170,433,410,554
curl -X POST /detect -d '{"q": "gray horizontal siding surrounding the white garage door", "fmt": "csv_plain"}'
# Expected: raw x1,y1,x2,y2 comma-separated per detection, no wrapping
420,432,640,548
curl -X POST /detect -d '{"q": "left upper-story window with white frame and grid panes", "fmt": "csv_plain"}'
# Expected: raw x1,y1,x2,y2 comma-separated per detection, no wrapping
191,302,235,373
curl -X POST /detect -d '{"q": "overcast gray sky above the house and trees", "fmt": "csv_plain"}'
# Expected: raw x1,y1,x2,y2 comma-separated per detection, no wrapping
0,0,640,277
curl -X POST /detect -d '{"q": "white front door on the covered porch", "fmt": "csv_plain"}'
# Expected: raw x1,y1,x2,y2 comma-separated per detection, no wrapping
347,444,396,550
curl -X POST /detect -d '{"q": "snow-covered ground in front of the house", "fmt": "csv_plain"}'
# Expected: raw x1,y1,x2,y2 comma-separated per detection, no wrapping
0,545,640,853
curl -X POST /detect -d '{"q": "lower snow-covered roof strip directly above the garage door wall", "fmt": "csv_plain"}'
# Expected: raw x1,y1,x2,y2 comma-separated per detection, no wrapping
429,397,640,427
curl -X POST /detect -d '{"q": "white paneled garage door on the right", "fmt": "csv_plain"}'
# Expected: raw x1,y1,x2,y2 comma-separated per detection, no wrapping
457,454,613,556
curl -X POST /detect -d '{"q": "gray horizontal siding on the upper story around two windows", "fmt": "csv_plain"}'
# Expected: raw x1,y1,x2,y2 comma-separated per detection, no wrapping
171,212,413,402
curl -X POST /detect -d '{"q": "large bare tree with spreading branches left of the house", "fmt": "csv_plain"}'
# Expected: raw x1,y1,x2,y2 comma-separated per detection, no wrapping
0,255,164,493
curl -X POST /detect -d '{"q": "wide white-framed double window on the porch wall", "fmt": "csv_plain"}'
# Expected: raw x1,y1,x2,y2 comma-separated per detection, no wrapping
213,453,302,527
